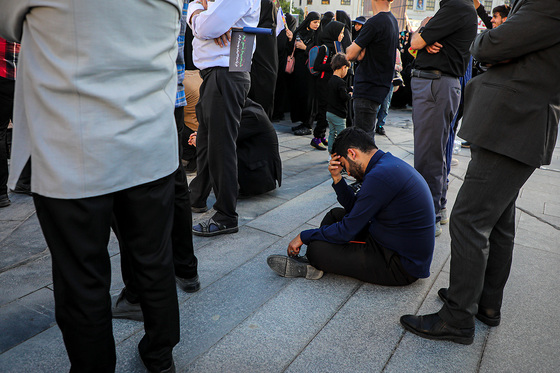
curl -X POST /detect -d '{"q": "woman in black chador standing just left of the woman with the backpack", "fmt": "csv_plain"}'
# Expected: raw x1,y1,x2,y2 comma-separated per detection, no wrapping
290,12,321,136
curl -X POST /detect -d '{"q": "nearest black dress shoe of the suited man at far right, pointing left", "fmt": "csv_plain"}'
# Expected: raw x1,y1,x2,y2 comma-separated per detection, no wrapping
401,313,474,345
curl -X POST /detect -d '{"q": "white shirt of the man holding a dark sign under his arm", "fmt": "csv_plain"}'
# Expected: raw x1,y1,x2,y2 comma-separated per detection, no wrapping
187,0,261,70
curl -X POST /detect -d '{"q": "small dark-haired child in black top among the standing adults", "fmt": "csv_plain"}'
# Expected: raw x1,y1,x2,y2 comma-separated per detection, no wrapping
327,53,352,153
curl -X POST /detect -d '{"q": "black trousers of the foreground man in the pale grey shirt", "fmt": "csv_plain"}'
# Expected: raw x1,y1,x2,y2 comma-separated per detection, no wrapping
33,175,179,372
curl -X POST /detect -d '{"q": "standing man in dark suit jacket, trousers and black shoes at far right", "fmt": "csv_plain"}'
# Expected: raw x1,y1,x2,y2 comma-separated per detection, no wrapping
401,0,560,344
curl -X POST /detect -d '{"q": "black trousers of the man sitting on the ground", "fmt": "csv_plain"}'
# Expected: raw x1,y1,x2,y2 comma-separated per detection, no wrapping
306,207,417,286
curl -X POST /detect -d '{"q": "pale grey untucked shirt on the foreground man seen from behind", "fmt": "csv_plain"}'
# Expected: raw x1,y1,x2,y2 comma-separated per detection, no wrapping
0,0,183,199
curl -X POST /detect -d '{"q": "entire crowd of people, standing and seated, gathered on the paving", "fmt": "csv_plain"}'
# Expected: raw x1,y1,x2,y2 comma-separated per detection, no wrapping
0,0,560,372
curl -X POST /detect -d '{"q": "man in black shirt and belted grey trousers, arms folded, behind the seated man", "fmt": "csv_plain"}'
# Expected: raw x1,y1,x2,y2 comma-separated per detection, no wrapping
411,0,477,236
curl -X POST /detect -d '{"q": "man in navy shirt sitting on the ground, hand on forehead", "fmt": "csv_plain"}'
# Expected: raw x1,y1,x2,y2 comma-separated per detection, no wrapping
267,127,435,286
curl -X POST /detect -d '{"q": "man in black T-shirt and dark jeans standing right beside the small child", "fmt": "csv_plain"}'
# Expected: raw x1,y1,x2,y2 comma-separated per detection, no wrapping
346,0,399,138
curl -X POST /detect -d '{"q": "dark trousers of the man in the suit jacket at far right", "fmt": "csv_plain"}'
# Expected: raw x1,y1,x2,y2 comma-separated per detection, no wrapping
439,144,535,327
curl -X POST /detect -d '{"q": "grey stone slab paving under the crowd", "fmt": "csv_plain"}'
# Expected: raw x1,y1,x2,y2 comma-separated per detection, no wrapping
0,110,560,372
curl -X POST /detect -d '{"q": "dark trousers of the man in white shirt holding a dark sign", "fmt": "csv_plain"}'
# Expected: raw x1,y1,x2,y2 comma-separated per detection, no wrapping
190,67,251,227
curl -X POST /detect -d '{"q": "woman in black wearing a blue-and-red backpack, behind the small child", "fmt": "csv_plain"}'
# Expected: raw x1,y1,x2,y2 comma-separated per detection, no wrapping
311,21,344,150
